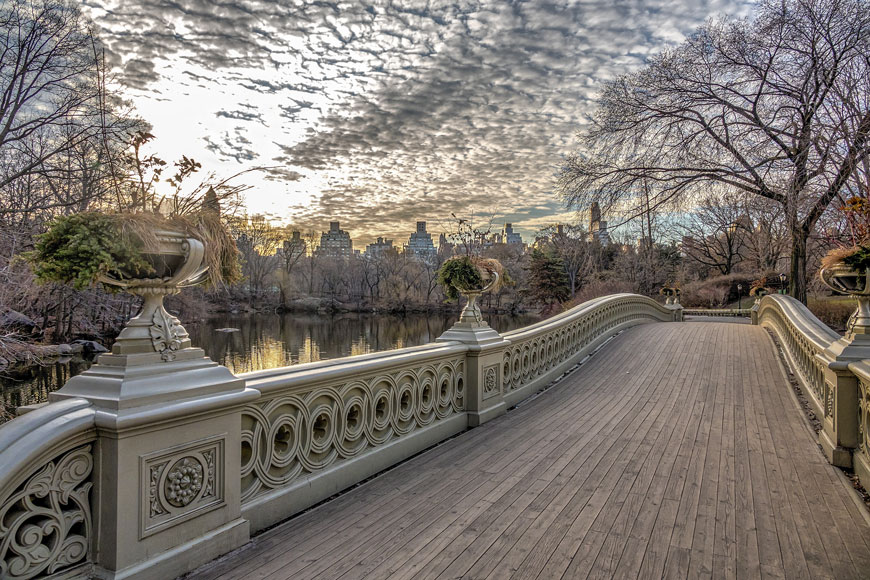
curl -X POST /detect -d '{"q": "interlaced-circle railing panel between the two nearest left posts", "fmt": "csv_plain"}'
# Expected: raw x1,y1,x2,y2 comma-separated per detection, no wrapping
241,357,465,502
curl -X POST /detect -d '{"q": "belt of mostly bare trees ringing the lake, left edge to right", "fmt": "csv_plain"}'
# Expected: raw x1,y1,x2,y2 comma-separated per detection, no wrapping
0,0,870,360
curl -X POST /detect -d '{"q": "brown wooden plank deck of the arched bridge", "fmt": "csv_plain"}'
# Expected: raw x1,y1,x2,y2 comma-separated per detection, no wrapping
189,322,870,580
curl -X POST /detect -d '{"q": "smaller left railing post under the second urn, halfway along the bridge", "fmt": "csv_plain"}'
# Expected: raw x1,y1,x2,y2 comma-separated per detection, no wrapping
437,309,510,427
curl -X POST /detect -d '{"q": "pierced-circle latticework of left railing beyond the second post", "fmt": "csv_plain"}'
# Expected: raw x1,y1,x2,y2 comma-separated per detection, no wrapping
502,298,662,392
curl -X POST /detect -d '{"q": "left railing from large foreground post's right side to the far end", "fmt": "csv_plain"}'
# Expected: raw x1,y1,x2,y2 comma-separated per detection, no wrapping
240,294,679,530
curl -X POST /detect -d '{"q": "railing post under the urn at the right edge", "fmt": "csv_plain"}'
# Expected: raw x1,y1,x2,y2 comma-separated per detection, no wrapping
816,327,870,467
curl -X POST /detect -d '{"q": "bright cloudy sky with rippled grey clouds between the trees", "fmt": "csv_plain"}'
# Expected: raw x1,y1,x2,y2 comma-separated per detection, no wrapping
84,0,748,247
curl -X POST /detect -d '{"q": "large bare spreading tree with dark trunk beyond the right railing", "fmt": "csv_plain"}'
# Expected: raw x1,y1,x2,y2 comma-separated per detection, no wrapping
561,0,870,300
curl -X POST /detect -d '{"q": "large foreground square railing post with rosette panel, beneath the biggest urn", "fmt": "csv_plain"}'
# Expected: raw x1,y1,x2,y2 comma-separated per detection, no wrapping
50,304,259,579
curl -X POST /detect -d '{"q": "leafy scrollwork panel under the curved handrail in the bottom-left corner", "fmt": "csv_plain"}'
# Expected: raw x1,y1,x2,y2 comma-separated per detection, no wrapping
0,445,94,580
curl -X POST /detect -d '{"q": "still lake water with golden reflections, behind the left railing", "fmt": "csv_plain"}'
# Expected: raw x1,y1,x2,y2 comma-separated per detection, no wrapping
0,314,540,408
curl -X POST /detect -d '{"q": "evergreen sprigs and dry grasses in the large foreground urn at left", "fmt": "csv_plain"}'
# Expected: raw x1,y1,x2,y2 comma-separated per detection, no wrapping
25,132,246,291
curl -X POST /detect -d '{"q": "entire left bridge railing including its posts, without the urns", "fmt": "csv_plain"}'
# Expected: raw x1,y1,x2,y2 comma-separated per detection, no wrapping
0,294,681,579
